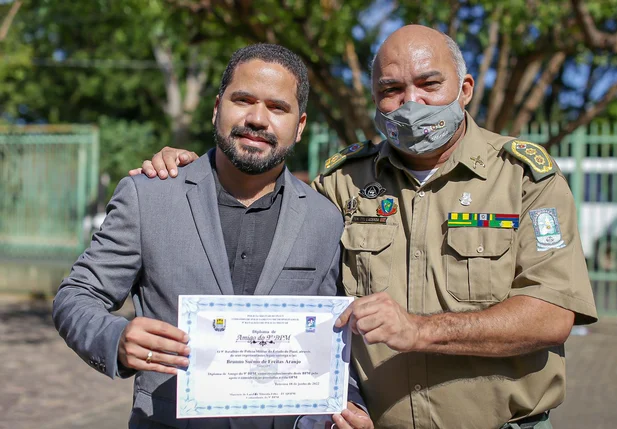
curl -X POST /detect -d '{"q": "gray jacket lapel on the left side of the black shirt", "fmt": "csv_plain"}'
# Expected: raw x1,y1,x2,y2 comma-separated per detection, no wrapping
186,155,234,295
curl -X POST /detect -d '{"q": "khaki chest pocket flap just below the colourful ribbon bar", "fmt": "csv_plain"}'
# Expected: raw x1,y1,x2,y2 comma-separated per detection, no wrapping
448,227,514,258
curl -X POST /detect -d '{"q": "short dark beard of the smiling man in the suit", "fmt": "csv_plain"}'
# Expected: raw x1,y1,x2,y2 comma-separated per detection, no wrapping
214,121,294,175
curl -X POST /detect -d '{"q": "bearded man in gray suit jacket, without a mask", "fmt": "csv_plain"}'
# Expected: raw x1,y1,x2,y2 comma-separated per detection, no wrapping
53,45,373,429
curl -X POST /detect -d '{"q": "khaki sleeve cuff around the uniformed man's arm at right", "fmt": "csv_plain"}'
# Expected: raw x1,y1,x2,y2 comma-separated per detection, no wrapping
510,285,598,325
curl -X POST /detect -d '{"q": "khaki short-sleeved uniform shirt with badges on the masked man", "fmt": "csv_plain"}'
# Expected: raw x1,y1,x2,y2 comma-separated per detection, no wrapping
313,115,597,429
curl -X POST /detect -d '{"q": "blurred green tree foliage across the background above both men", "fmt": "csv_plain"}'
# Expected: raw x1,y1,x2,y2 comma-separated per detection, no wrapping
0,0,617,185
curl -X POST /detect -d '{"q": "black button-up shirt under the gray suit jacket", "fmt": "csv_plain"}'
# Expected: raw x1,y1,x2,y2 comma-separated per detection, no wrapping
210,154,285,295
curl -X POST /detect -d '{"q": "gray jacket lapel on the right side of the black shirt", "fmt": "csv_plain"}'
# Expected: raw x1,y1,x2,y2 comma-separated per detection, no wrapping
255,169,307,295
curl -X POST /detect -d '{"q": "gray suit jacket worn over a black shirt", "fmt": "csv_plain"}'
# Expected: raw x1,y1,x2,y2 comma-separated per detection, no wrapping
53,155,352,428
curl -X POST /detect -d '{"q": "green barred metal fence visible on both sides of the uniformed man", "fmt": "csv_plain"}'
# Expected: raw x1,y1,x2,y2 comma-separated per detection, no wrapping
309,122,617,316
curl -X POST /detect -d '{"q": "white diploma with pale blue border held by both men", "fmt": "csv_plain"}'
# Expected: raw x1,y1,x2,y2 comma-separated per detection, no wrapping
176,295,353,418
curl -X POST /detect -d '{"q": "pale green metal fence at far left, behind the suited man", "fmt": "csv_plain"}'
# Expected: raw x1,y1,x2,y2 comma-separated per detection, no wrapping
0,125,99,259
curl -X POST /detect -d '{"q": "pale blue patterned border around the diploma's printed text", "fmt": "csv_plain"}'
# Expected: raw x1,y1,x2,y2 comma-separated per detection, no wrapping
176,295,353,418
